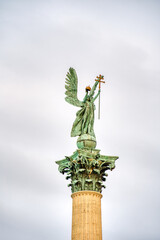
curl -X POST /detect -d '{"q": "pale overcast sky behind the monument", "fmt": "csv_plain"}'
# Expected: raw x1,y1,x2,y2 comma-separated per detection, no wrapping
0,0,160,240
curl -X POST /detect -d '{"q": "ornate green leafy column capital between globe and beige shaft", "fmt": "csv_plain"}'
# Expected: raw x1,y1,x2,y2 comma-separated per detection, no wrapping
56,148,118,193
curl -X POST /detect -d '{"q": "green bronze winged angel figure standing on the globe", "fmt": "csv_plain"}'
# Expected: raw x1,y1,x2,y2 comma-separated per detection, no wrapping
65,68,103,141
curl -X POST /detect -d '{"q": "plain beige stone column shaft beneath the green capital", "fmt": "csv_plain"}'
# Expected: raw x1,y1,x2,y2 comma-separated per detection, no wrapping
71,191,102,240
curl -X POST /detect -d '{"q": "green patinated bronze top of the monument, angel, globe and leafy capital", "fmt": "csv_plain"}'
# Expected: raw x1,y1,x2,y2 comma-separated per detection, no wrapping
56,68,118,193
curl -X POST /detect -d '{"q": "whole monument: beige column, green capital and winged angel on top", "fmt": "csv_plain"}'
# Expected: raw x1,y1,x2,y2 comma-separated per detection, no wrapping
56,68,118,240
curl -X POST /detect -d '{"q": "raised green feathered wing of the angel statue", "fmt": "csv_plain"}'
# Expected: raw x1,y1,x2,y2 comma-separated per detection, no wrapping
65,68,83,107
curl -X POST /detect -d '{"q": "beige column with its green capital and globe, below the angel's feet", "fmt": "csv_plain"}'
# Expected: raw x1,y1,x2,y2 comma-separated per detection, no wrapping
56,146,118,240
